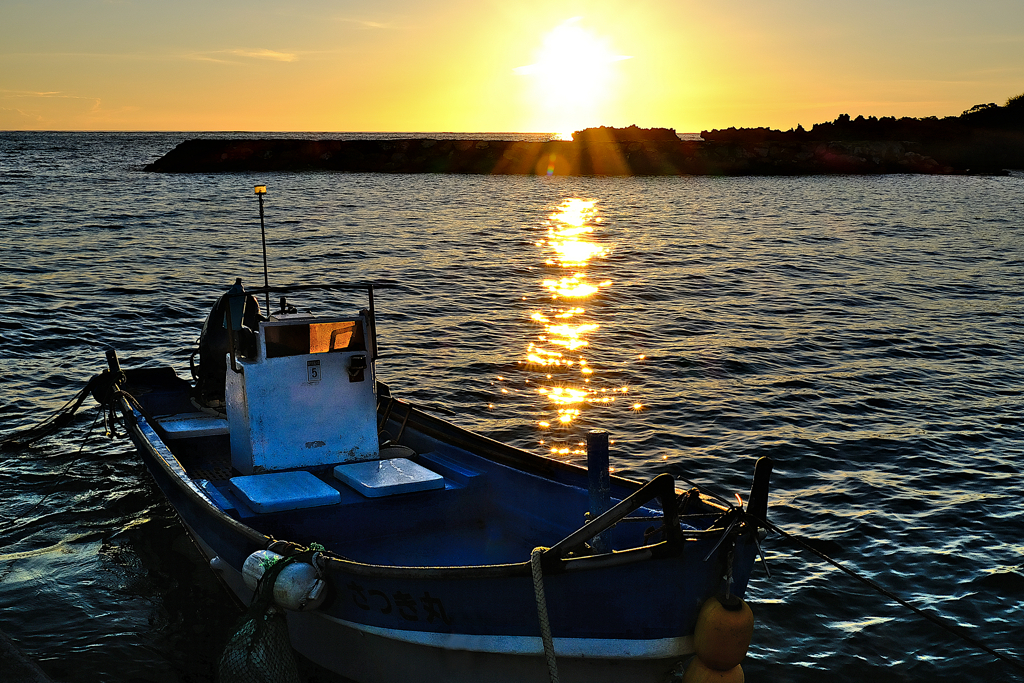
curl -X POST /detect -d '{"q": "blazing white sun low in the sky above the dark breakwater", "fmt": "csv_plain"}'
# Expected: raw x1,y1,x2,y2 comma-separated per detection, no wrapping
515,16,630,138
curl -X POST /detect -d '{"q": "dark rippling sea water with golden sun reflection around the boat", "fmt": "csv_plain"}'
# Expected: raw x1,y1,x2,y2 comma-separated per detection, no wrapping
0,133,1024,683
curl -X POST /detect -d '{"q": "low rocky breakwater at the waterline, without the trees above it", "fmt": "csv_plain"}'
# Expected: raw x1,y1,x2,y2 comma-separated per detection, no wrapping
145,139,968,176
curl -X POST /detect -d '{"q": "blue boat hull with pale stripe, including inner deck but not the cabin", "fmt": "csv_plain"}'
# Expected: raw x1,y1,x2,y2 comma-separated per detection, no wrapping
123,371,757,683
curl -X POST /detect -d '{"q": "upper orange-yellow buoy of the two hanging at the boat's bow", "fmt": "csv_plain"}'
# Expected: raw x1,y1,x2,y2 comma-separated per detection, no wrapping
693,595,754,672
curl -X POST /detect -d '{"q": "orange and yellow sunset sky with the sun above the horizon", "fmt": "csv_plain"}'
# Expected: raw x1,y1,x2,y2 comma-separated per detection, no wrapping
0,0,1024,132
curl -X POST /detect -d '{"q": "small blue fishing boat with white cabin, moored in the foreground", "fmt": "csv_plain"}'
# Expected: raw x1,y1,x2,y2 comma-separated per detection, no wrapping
108,280,770,683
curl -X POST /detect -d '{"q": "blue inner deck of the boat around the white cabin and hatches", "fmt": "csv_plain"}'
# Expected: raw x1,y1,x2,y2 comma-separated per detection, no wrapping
123,369,721,566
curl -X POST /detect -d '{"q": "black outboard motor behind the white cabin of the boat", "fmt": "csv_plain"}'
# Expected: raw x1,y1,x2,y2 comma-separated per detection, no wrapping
189,278,266,409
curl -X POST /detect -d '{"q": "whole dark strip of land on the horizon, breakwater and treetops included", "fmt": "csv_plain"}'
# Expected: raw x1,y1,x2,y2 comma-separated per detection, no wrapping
145,94,1024,175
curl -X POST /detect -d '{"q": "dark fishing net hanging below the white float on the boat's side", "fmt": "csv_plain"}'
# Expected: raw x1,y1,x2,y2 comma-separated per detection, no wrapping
217,558,301,683
